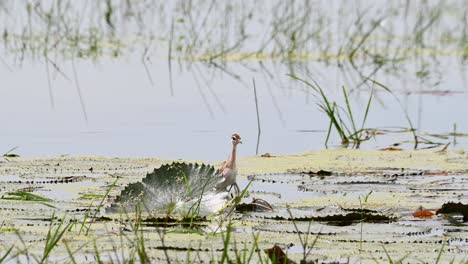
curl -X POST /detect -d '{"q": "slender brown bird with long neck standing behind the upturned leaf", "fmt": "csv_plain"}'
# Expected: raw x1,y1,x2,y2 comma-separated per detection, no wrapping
216,133,242,195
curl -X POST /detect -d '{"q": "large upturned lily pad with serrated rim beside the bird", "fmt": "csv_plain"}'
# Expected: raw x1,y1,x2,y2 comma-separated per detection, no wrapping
108,162,227,214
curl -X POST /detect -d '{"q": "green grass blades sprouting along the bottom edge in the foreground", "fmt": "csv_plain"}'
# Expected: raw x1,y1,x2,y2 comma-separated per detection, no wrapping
0,206,460,264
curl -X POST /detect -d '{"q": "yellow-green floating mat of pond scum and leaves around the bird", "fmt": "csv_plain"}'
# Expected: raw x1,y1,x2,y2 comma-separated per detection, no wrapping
0,150,468,263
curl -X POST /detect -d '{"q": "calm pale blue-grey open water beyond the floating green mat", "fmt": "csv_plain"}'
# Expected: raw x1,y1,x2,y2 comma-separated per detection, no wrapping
0,1,468,160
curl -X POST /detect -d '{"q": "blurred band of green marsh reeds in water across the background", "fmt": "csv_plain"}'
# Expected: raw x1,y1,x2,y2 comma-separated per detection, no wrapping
0,0,468,92
